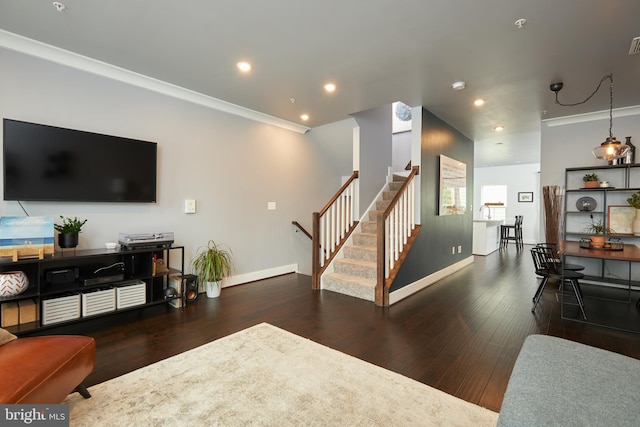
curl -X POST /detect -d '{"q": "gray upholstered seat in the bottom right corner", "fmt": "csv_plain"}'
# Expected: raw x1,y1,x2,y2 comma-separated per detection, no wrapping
498,335,640,427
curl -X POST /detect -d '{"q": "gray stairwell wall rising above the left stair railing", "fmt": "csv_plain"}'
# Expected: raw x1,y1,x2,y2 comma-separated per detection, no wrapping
353,104,392,216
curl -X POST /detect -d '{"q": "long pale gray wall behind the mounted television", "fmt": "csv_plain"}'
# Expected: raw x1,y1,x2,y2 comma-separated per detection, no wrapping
0,48,354,282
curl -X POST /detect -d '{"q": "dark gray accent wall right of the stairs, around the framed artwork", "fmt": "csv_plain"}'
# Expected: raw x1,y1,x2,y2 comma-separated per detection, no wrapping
391,108,473,291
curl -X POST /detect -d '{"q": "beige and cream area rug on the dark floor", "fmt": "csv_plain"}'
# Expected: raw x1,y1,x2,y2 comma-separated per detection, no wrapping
66,323,498,427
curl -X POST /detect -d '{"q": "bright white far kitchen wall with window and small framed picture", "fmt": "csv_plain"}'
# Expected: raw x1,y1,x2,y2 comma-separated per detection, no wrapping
473,163,542,244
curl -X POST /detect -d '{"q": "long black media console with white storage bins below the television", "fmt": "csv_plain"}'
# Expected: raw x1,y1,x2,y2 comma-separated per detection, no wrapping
0,245,185,335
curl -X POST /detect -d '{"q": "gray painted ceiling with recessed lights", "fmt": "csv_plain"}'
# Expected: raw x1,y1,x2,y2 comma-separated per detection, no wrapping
0,0,640,166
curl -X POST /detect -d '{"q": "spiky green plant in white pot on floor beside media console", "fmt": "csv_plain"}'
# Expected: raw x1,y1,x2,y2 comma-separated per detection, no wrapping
193,240,231,298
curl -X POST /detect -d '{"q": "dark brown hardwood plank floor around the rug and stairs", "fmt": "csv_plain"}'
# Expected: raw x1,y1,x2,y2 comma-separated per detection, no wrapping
35,247,640,411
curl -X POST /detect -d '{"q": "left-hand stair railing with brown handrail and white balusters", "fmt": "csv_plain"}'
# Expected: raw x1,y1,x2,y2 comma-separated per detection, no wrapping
311,171,358,290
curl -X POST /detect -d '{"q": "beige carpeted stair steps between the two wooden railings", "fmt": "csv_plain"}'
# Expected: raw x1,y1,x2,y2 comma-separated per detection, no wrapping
322,179,405,301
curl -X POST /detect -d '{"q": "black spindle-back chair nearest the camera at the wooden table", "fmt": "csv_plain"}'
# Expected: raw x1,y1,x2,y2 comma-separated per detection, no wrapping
531,246,587,320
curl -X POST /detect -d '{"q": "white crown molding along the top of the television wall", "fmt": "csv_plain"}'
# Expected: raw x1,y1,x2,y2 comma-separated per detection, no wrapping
0,29,310,134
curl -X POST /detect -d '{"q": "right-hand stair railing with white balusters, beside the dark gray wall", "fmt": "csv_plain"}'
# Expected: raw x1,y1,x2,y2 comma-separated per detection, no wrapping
375,166,420,307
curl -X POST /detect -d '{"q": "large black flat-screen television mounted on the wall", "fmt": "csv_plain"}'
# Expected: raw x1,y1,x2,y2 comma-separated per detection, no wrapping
3,119,157,203
